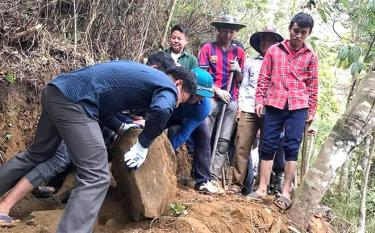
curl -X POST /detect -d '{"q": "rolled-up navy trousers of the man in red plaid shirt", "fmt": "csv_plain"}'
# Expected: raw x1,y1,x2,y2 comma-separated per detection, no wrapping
260,106,307,161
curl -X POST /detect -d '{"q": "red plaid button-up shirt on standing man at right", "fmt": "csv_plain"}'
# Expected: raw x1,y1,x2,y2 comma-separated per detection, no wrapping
255,40,318,116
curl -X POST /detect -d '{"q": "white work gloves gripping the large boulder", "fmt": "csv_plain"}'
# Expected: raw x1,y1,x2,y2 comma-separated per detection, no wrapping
118,123,148,169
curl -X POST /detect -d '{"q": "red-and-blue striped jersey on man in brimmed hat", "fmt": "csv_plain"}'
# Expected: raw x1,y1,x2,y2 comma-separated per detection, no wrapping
198,42,245,101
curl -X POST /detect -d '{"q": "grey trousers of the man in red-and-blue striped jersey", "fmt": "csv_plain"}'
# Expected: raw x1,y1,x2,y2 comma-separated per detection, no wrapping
207,98,238,179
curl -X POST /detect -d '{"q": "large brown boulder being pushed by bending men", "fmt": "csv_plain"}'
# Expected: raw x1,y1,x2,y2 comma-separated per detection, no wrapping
110,129,177,221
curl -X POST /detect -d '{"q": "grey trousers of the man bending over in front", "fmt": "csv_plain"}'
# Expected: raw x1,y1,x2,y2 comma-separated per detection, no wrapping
0,84,110,233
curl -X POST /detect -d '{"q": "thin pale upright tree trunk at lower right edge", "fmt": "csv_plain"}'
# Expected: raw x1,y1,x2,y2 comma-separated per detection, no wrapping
358,131,375,233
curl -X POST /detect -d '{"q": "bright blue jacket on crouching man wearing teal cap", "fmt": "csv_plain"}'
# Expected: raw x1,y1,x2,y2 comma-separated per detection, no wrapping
167,97,211,150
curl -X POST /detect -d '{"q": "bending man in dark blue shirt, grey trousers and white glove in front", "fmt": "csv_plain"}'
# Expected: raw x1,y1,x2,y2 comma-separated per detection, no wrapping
0,57,196,233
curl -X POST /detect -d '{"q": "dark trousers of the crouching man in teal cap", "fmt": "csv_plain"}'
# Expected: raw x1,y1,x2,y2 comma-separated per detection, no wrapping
168,121,212,186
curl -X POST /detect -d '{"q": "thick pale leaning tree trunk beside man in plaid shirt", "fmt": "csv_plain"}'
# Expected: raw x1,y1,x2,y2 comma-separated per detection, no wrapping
289,62,375,227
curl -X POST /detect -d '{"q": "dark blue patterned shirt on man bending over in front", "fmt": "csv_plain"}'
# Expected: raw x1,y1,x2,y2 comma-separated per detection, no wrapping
50,61,177,147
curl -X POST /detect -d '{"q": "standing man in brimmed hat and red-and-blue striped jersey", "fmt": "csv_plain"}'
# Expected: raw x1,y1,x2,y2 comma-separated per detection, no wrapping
198,15,246,189
